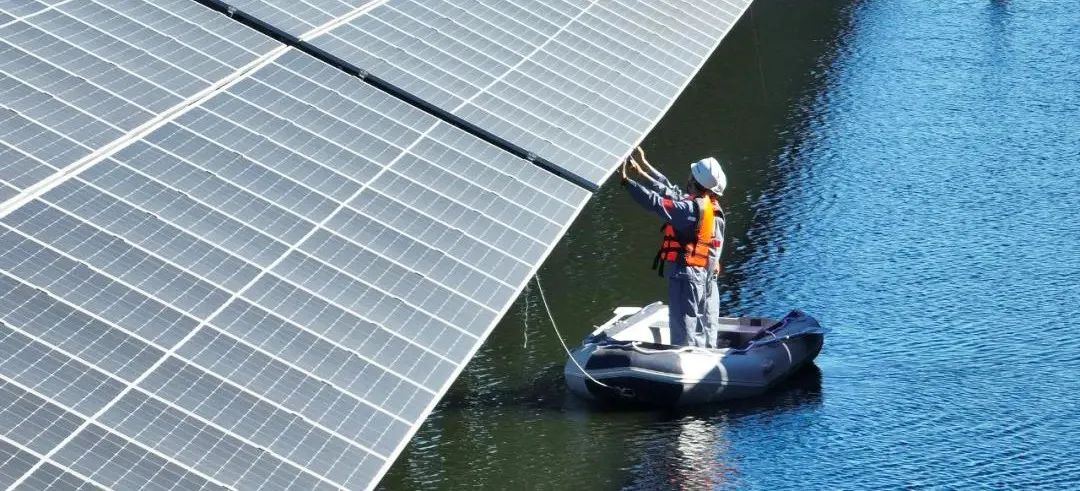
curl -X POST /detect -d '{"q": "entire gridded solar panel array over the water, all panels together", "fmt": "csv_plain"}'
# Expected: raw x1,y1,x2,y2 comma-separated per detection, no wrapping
0,0,751,489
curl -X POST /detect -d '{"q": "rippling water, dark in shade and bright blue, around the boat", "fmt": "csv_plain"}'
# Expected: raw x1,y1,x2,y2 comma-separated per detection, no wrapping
381,0,1080,489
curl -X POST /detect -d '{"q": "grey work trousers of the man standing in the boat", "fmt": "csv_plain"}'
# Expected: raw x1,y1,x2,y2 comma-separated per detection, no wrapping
667,268,720,347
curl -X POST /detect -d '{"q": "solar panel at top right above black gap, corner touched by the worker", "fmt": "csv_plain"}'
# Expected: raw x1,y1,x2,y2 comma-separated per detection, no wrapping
300,0,751,185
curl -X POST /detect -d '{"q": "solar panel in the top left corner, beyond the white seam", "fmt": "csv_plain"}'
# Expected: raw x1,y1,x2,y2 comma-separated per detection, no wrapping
0,0,278,197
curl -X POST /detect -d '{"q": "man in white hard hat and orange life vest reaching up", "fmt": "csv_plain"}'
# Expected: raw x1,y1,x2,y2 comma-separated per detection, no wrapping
622,147,728,347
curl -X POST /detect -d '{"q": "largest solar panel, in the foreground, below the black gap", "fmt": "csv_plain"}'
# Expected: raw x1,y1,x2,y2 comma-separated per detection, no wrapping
0,51,589,489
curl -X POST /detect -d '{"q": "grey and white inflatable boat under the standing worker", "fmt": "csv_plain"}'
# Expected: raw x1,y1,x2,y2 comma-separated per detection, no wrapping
563,302,825,406
